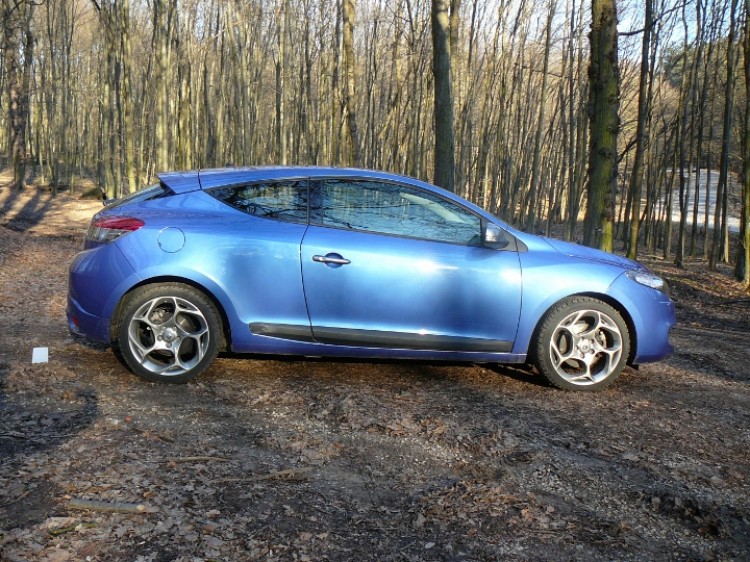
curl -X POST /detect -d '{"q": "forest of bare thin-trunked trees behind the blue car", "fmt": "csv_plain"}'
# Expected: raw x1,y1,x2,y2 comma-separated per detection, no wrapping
0,0,750,288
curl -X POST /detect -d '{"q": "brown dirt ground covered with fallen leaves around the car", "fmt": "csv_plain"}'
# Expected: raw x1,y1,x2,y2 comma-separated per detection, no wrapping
0,184,750,562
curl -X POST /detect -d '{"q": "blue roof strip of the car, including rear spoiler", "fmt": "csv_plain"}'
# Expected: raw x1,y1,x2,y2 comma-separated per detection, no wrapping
157,166,434,193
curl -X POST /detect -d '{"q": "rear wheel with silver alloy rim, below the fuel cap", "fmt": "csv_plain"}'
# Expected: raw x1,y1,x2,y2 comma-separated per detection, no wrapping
113,283,223,383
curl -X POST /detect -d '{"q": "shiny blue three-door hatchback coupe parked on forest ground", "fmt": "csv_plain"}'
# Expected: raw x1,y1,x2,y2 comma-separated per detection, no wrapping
67,167,675,390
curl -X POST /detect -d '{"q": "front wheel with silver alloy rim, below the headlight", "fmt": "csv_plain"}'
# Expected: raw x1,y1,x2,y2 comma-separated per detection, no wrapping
531,297,630,392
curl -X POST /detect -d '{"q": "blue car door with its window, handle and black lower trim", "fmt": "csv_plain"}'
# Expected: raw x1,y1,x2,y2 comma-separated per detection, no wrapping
301,179,521,352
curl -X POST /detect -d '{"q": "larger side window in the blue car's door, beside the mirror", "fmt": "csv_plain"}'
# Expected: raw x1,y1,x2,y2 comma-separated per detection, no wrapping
312,179,481,244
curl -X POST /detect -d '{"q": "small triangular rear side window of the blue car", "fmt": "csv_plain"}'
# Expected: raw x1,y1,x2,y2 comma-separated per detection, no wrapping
208,180,307,223
